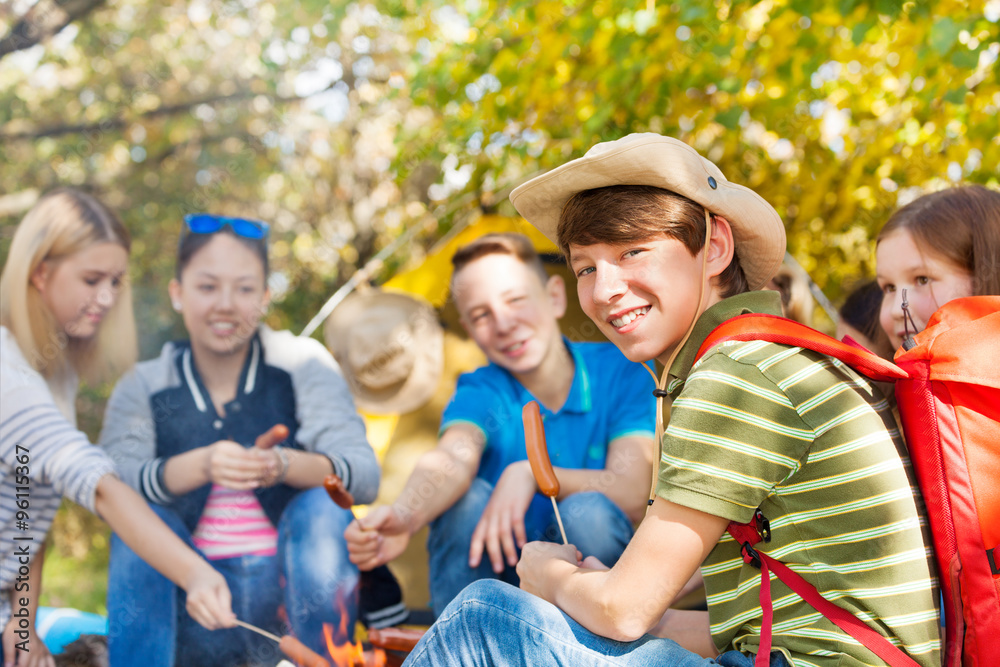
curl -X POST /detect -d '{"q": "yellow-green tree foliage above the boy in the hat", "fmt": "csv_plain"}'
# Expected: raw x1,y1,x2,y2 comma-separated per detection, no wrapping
390,0,1000,297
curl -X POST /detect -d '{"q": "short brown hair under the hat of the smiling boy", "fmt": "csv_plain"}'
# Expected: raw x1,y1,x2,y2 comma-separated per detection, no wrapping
557,185,750,298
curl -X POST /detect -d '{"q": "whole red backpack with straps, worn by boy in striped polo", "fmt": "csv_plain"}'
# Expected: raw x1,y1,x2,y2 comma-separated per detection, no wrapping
696,296,1000,667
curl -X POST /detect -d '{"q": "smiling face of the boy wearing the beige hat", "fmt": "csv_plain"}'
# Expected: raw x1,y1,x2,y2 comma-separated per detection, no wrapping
569,236,719,363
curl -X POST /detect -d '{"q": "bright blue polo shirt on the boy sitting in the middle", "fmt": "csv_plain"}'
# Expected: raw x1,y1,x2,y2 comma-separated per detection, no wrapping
439,339,656,528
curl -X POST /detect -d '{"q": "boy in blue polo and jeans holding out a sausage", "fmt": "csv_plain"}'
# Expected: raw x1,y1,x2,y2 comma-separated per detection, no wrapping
345,234,655,613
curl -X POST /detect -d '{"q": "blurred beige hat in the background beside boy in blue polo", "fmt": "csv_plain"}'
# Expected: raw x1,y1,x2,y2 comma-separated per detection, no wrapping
323,289,444,414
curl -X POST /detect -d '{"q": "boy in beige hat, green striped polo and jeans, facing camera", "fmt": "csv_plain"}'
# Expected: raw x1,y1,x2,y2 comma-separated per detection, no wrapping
407,134,941,667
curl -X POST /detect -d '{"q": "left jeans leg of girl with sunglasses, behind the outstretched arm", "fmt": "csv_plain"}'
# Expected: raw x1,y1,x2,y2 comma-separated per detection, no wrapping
107,505,192,667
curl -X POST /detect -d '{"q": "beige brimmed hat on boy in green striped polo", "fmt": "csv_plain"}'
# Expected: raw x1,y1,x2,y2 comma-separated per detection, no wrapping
510,133,785,290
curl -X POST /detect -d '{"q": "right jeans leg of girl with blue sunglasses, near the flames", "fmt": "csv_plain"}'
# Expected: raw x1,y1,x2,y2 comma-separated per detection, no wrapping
278,487,359,654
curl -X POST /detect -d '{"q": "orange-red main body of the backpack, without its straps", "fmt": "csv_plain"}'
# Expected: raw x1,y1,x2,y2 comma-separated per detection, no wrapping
895,296,1000,667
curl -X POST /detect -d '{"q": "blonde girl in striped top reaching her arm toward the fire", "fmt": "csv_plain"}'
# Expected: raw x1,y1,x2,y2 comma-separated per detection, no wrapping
0,189,233,667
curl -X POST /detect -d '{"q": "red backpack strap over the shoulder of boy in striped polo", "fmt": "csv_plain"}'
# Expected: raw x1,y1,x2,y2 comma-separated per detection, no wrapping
695,314,909,382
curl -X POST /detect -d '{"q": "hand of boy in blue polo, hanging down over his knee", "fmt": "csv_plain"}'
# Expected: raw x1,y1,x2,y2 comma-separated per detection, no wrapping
469,461,538,574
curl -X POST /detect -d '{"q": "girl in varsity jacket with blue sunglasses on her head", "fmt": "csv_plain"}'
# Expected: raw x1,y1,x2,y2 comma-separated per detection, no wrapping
101,214,379,667
